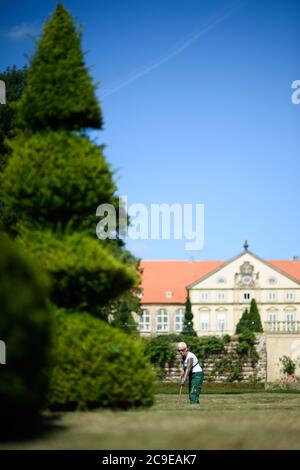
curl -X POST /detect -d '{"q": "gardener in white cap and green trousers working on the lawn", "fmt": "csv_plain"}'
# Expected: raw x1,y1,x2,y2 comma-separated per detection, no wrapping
177,342,204,405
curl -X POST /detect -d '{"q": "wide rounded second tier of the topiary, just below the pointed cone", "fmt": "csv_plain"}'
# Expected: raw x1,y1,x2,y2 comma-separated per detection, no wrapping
0,131,116,230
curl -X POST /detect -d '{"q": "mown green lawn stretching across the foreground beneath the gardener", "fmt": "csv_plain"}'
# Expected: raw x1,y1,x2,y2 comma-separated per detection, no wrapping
0,392,300,450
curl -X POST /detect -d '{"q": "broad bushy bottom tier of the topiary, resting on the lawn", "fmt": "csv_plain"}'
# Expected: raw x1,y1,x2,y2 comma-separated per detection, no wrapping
49,310,154,410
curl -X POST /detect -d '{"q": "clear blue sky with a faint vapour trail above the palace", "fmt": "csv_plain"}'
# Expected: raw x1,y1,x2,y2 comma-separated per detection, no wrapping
0,0,300,260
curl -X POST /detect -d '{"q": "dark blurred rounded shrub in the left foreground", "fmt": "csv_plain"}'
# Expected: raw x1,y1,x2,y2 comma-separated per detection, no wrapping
0,236,51,424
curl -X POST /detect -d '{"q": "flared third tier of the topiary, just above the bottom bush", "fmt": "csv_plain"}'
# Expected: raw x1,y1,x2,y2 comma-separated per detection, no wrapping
20,229,138,315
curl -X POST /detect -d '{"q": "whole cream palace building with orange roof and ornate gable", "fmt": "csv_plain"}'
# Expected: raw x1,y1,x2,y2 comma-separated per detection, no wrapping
135,242,300,336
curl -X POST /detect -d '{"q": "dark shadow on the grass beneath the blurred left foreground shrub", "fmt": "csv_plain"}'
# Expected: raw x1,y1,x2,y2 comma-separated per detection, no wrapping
0,413,66,443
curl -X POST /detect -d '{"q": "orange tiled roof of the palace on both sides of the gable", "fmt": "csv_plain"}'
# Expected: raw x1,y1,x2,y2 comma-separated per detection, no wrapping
141,260,300,304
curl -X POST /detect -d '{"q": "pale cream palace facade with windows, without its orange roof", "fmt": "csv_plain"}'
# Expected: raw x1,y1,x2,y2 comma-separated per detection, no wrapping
136,250,300,336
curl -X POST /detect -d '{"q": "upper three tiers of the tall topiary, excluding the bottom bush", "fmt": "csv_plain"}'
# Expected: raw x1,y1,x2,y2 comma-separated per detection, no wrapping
0,4,139,319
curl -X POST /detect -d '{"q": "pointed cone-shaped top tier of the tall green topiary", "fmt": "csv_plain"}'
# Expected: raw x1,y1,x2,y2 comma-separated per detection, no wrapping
19,4,102,132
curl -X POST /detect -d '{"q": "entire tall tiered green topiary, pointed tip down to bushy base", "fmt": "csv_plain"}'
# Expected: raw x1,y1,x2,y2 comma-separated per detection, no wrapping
0,1,152,408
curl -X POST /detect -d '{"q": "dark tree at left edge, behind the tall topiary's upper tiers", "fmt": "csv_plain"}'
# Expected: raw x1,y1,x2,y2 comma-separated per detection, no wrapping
0,66,27,171
